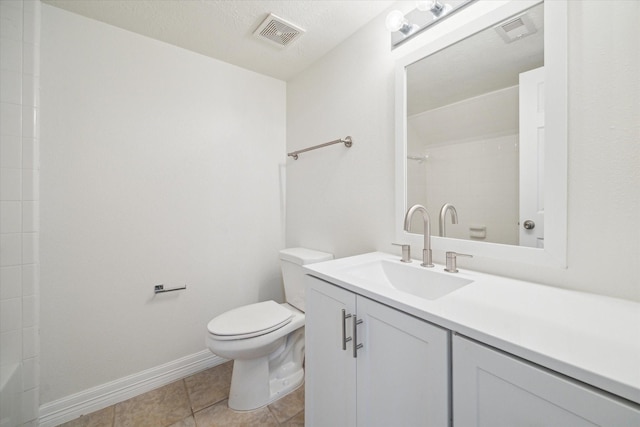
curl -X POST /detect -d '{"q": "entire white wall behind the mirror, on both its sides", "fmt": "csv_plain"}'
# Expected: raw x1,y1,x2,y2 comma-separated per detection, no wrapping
287,1,640,301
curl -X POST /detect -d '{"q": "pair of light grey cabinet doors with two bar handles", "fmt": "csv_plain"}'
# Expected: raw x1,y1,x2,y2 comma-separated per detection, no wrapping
305,276,450,427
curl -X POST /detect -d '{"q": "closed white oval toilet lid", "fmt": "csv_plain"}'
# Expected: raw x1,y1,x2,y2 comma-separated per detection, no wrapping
207,301,293,339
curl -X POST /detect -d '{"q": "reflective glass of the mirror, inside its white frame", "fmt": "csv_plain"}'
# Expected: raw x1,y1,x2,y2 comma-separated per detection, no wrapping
406,4,544,247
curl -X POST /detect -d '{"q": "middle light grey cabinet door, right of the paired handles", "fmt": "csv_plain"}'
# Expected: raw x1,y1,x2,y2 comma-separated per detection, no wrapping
356,296,450,427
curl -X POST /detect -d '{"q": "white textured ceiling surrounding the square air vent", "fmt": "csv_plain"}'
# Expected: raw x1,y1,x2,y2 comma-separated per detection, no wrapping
43,0,394,81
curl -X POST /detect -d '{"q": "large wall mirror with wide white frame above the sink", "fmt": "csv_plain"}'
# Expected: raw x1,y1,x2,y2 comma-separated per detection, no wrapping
396,1,567,266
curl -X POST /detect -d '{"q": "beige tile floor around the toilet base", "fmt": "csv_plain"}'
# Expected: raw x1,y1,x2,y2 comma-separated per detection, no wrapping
61,362,304,427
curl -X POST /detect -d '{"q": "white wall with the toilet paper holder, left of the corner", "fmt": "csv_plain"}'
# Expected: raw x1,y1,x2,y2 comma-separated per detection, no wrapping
41,5,285,403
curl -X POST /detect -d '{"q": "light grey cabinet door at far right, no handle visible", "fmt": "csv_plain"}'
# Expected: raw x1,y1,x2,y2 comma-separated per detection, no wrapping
453,336,640,427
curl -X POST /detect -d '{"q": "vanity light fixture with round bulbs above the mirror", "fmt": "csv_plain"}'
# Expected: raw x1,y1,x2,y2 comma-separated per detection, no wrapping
385,0,475,49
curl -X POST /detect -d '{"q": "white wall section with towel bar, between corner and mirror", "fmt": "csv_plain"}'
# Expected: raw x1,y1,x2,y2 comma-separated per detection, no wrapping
286,4,394,257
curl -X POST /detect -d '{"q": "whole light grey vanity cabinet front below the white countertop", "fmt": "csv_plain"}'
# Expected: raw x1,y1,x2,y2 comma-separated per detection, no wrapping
305,276,640,427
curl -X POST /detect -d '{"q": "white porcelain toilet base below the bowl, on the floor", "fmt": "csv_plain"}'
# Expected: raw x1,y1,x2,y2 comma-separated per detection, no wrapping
228,328,304,411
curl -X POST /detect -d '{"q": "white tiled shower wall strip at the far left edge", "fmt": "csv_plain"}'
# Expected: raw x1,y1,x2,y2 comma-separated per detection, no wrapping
0,0,40,425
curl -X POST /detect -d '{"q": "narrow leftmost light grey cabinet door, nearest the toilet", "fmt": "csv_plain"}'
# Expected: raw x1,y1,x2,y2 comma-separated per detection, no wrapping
305,276,356,427
